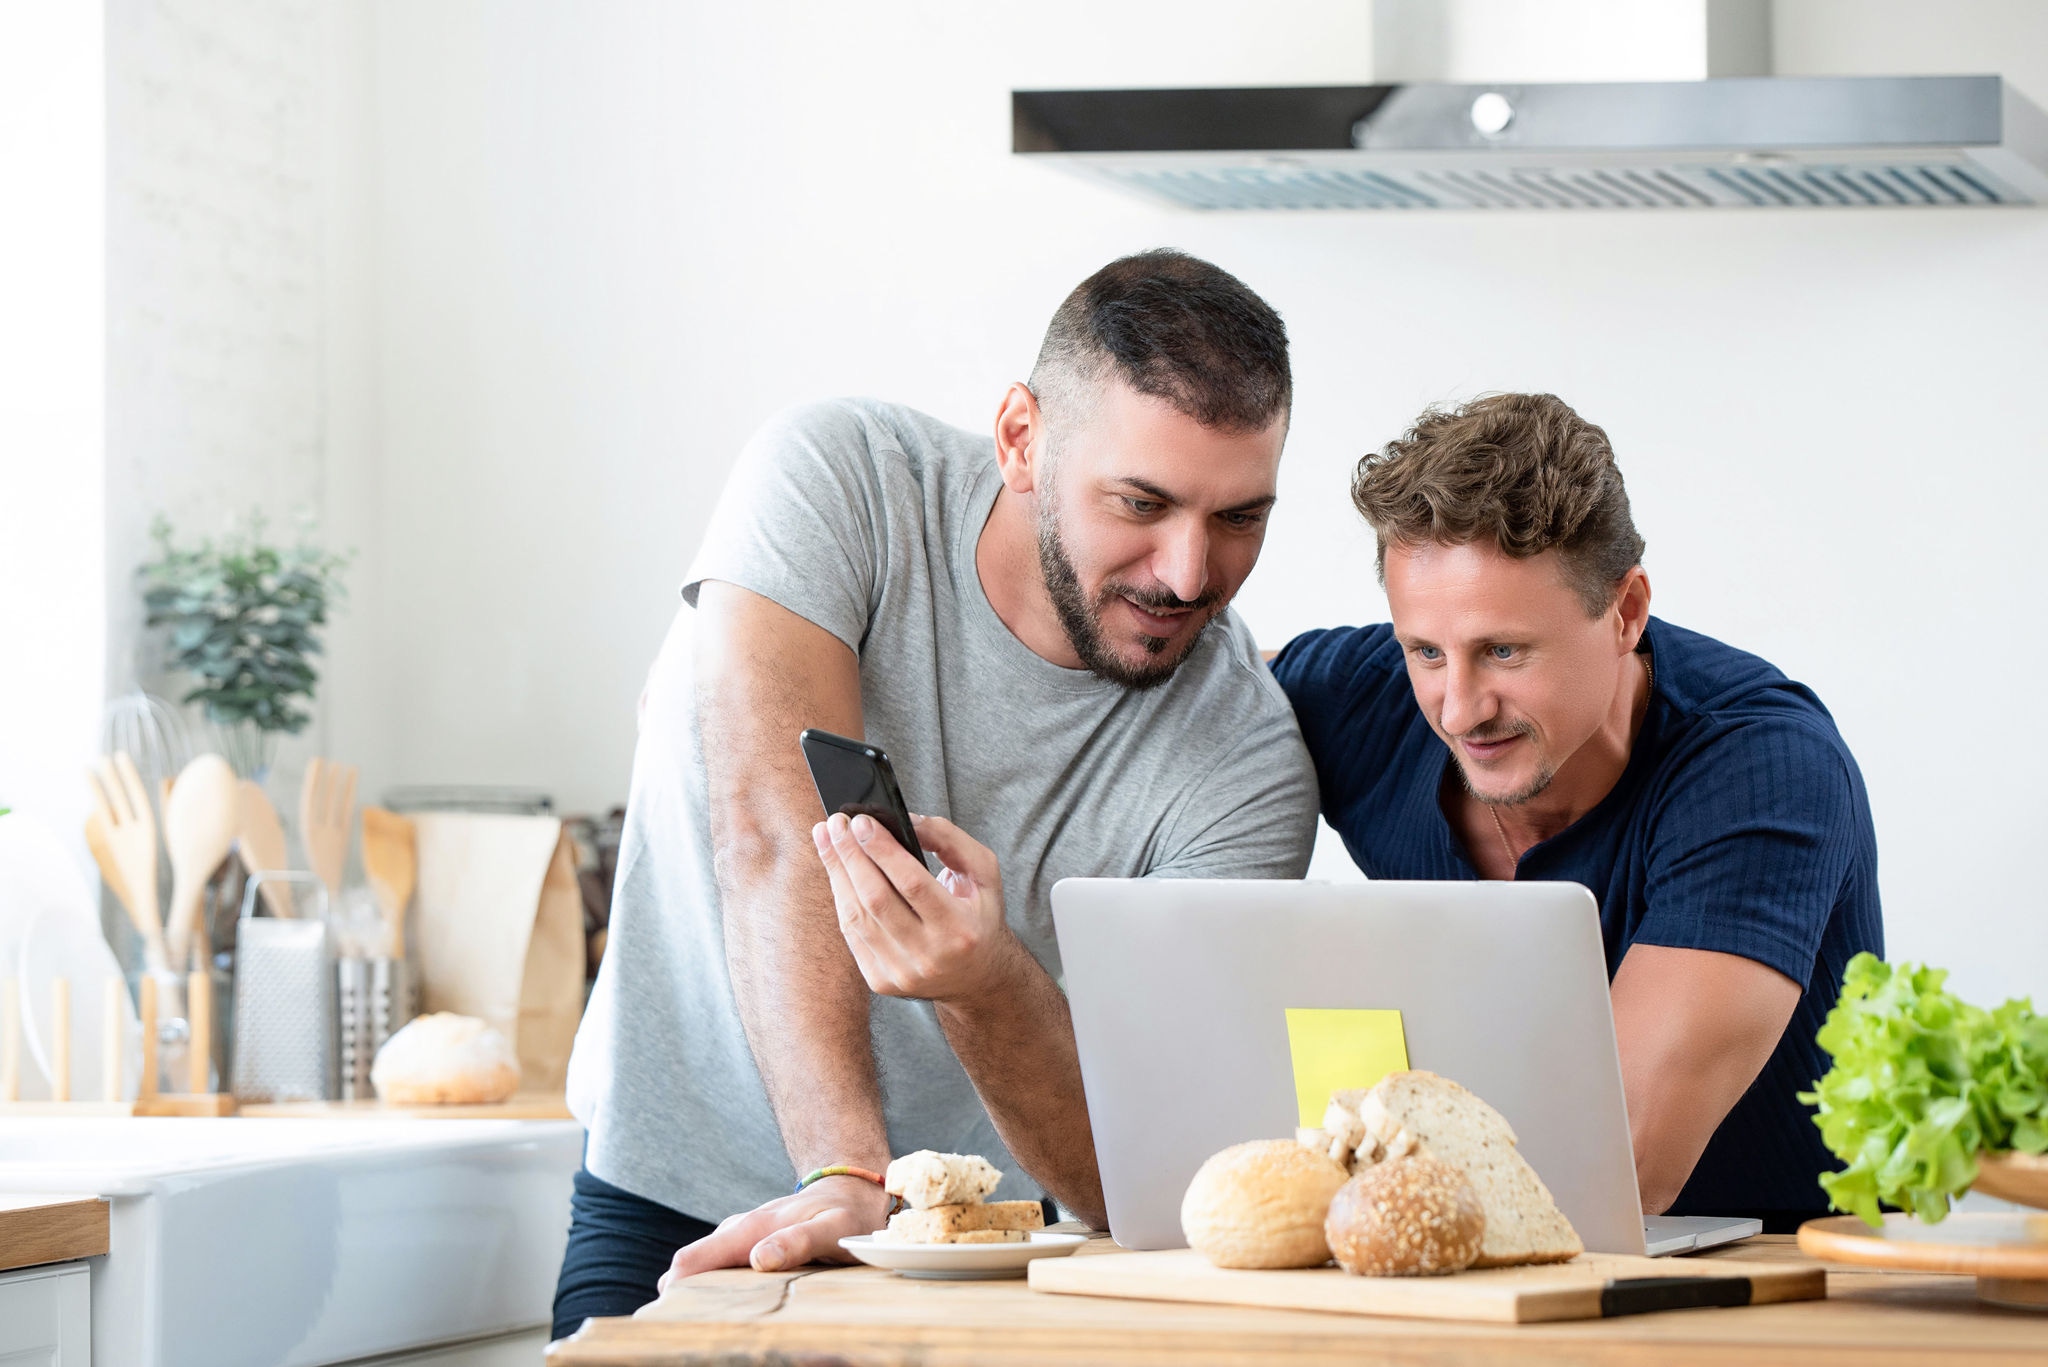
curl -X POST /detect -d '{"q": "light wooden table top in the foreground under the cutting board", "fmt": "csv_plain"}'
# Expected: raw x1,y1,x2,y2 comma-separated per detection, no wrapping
547,1236,2048,1367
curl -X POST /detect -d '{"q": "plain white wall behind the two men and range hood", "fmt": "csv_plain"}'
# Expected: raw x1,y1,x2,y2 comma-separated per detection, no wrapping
336,0,2048,998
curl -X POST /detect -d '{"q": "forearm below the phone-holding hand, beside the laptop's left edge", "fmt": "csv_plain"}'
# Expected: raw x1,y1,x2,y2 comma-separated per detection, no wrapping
938,943,1110,1230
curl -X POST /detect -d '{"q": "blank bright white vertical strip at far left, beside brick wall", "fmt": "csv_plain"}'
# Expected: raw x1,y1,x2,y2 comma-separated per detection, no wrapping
0,0,106,855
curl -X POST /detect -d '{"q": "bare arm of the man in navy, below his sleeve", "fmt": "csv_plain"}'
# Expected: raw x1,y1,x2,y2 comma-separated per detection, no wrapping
1614,945,1802,1215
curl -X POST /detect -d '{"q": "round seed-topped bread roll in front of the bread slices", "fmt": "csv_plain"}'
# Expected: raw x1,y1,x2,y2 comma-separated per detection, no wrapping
1323,1156,1487,1277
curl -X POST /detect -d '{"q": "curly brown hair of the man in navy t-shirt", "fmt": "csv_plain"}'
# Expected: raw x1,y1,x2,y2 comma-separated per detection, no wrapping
1352,393,1642,617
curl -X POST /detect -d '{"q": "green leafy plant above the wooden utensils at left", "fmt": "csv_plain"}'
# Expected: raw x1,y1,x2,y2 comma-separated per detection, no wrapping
137,514,348,781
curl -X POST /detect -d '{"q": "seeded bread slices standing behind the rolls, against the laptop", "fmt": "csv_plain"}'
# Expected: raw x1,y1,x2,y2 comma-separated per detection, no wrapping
1358,1070,1585,1267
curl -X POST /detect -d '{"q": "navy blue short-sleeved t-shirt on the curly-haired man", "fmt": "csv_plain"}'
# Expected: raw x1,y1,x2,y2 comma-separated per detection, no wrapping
1274,617,1884,1215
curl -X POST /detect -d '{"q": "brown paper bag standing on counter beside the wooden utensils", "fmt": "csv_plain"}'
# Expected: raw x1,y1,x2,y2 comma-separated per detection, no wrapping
412,812,584,1092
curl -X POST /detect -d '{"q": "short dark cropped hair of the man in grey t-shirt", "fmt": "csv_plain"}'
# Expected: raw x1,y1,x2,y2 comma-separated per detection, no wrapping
1030,248,1294,432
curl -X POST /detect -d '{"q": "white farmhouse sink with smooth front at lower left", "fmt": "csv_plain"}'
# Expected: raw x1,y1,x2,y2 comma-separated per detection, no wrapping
0,1119,584,1367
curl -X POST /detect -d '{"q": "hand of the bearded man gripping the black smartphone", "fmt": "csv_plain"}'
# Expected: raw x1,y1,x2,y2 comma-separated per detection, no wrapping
811,816,1030,1002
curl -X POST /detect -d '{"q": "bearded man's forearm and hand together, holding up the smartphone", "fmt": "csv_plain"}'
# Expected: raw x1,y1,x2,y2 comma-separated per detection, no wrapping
813,816,1108,1230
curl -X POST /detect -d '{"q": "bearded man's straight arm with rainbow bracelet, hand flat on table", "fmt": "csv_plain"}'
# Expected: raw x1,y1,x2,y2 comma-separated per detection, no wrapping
664,580,889,1285
